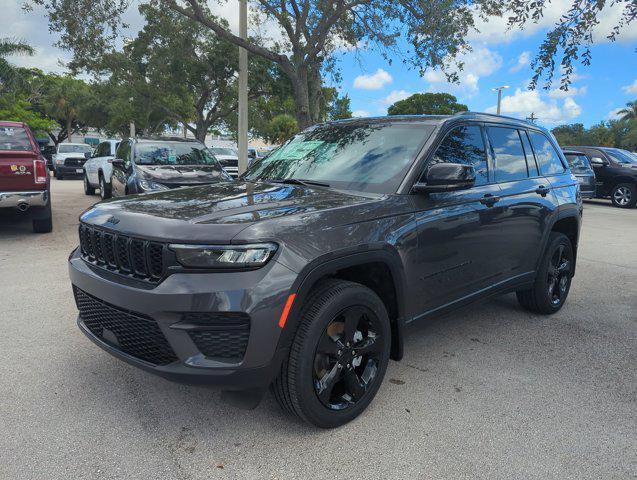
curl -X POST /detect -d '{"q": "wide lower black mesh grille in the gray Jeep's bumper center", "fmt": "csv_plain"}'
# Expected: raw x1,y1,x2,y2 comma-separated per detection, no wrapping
73,287,178,365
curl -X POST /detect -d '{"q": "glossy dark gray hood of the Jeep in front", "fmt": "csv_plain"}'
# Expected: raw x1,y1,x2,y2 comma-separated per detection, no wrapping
81,182,384,243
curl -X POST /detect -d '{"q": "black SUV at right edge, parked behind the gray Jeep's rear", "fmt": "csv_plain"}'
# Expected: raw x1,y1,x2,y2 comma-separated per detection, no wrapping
564,146,637,208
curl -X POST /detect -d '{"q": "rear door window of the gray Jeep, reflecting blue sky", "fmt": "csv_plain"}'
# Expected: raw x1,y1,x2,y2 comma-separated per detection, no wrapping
487,127,529,182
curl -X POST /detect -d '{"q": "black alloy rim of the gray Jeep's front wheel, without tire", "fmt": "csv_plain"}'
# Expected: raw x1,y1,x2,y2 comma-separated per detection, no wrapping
313,305,382,410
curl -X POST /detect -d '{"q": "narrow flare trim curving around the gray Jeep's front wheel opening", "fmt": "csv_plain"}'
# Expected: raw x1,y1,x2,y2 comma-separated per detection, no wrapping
277,244,405,360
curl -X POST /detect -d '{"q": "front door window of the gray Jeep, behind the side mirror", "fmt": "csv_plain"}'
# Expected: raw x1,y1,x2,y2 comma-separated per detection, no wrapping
428,125,489,185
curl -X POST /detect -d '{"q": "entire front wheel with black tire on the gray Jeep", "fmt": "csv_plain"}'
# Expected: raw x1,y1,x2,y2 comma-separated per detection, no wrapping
273,280,391,428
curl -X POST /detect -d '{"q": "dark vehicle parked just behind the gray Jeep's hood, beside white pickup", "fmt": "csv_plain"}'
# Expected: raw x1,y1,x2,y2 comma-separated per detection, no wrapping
111,138,231,197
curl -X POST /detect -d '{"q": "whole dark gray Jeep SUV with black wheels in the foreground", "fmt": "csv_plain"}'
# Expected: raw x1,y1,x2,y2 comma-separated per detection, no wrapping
69,114,582,427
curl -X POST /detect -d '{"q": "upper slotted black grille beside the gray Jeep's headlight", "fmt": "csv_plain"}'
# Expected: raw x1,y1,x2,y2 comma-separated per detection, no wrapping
79,223,166,283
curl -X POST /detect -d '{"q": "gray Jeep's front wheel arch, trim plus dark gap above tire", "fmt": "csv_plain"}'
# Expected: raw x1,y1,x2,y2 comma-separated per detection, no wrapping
279,246,406,360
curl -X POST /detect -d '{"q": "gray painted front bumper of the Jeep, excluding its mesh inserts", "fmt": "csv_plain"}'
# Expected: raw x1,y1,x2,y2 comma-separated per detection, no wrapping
69,250,296,390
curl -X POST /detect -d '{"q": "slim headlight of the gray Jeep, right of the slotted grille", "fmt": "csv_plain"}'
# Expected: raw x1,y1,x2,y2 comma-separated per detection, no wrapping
170,243,277,268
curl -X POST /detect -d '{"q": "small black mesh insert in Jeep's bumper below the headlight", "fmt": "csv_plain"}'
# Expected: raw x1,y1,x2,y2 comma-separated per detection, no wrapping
182,312,250,362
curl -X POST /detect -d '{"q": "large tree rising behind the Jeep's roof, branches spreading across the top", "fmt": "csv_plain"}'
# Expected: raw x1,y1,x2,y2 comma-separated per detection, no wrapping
31,0,637,128
